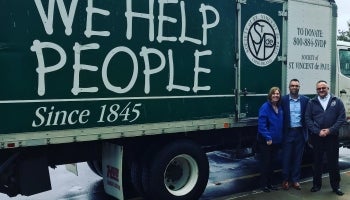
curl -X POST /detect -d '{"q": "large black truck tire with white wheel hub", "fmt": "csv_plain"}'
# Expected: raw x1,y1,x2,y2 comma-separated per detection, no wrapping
142,140,209,200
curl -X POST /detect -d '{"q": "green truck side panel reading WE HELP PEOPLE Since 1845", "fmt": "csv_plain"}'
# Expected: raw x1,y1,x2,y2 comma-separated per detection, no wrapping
0,0,236,134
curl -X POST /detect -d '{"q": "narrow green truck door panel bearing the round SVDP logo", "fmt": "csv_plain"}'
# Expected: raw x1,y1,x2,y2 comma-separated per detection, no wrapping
237,0,283,117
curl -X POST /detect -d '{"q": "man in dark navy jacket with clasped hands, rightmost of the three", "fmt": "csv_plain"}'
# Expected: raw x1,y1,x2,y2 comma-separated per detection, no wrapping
305,80,346,196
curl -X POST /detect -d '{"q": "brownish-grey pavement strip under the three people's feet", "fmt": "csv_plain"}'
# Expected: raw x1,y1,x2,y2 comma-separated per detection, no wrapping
215,170,350,200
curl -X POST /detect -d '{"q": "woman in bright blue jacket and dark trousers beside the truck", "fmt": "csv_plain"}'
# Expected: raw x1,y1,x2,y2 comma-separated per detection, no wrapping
258,87,283,192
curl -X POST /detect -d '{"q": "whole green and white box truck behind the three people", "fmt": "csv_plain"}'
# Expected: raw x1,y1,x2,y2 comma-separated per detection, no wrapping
0,0,350,200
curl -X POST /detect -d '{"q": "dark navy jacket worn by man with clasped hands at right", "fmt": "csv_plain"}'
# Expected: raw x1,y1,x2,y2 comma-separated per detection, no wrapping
305,95,346,135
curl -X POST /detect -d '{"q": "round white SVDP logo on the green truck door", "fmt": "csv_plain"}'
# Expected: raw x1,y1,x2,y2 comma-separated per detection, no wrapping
243,13,280,67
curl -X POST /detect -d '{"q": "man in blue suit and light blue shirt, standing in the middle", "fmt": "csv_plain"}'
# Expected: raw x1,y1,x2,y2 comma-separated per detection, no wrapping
282,79,309,190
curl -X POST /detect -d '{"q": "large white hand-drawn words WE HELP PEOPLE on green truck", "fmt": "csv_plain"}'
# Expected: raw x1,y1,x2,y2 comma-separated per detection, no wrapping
31,0,220,96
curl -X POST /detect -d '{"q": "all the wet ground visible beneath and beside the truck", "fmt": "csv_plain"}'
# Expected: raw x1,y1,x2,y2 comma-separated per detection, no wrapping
0,149,350,200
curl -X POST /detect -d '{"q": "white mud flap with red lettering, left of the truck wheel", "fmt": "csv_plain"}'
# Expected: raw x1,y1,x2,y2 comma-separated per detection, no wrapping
102,142,124,200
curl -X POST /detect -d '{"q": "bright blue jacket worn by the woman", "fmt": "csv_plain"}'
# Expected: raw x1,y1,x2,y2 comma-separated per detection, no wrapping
258,102,283,144
